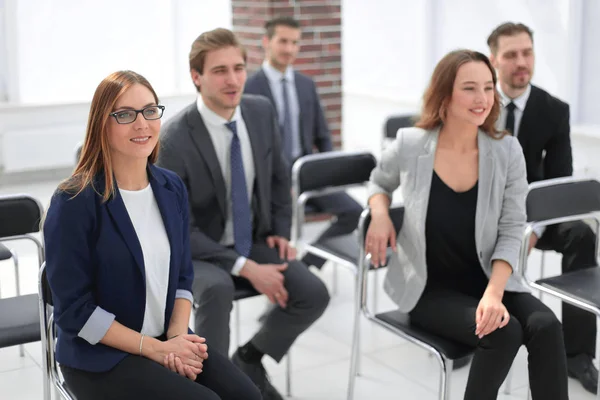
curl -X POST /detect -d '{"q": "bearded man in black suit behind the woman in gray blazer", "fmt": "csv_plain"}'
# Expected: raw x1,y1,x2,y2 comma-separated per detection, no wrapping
488,23,598,393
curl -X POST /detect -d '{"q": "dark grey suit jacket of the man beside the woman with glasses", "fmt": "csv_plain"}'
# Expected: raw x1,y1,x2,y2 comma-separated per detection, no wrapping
158,95,292,271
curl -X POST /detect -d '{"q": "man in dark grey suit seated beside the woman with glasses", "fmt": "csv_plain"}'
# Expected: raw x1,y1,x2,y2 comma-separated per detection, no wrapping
159,29,329,399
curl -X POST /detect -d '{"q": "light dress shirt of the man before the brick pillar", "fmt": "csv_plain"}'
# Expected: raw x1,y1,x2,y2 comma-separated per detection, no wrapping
262,60,302,160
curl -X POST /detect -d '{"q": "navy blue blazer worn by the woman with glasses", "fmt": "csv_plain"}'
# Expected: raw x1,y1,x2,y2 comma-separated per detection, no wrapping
44,165,194,372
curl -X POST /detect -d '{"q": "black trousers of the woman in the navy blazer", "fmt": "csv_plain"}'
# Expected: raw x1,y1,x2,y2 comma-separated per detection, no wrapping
61,345,262,400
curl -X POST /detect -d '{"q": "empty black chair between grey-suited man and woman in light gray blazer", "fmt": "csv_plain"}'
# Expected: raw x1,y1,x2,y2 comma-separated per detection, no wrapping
291,151,376,293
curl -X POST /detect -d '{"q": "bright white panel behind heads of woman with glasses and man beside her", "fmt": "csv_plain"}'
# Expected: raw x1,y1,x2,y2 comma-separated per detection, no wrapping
6,0,231,104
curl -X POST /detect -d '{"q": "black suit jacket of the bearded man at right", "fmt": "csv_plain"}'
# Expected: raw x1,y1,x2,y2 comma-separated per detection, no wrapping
518,85,573,183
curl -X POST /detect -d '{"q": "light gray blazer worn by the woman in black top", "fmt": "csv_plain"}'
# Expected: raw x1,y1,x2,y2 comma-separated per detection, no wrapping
369,128,528,312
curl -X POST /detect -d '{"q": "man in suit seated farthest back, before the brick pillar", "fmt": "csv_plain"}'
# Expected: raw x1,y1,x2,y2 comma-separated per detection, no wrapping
245,17,362,268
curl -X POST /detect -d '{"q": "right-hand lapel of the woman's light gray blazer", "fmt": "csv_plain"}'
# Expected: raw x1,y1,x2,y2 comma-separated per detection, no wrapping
475,130,495,251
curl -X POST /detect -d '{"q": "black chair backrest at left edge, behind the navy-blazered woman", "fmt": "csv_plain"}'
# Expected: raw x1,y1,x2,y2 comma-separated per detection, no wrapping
0,194,43,238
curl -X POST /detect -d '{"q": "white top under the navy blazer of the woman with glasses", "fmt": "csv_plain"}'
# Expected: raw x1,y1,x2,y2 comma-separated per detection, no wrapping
119,185,171,337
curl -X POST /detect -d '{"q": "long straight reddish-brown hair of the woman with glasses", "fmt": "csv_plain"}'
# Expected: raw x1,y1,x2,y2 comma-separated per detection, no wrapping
58,71,159,202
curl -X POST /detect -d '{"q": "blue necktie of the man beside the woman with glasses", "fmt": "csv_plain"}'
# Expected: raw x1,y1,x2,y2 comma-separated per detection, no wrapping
225,121,252,257
